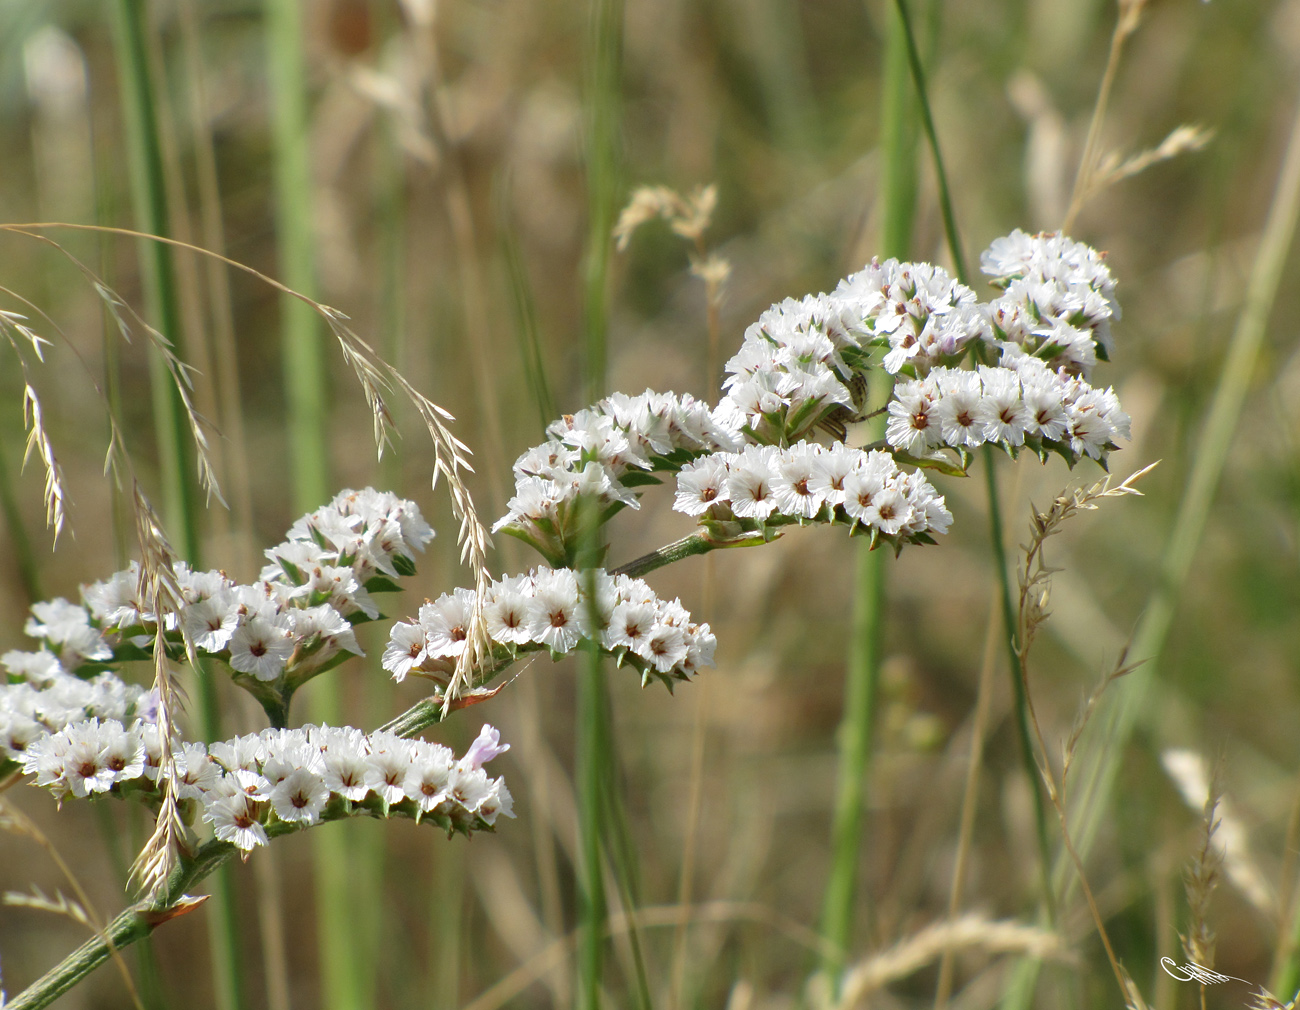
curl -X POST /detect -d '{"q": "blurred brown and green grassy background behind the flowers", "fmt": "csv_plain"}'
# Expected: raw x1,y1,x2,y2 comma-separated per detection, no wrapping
0,0,1300,1010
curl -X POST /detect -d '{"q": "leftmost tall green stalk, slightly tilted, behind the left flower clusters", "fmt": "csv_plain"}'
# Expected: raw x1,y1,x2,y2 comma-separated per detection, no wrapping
113,0,243,1010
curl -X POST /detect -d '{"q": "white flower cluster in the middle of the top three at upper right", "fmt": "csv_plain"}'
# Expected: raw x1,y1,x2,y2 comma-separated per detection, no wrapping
833,259,989,376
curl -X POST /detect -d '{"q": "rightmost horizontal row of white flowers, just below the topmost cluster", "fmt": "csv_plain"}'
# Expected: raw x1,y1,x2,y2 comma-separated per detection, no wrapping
885,343,1130,460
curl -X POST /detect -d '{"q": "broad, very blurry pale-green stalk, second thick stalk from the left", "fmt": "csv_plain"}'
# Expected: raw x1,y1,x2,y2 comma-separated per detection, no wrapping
264,0,353,1010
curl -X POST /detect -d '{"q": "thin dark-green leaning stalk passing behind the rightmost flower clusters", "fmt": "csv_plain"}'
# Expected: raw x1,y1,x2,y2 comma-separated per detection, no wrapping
894,0,1054,924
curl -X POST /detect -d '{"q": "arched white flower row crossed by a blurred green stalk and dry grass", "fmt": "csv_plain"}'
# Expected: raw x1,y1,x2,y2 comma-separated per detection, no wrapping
384,568,716,682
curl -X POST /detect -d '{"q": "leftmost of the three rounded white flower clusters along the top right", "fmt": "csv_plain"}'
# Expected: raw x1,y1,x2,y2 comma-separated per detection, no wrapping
716,294,861,439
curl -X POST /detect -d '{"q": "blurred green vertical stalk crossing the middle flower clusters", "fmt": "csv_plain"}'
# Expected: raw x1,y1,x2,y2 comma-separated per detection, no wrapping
575,0,623,1010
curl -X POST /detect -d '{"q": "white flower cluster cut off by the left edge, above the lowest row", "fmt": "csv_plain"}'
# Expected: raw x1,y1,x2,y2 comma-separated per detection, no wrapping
0,649,152,766
